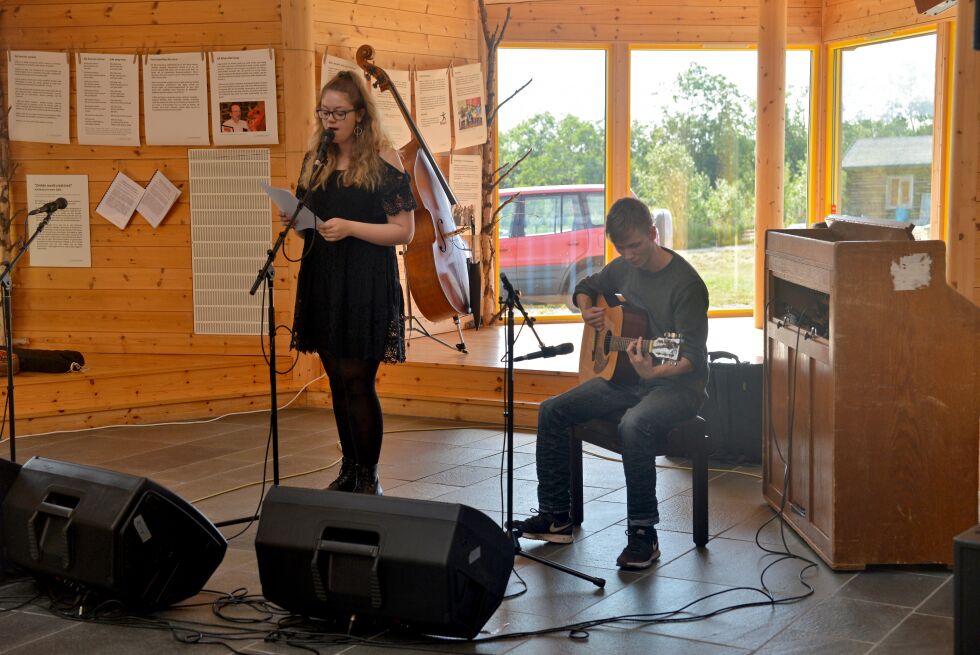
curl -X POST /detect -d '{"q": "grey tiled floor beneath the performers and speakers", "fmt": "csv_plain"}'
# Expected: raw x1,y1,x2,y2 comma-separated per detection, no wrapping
0,409,953,655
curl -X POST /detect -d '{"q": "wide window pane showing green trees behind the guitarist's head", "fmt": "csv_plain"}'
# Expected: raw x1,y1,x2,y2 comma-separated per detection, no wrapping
630,50,760,310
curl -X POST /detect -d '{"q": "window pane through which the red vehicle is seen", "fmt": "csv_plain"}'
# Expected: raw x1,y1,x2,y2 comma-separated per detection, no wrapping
497,48,606,316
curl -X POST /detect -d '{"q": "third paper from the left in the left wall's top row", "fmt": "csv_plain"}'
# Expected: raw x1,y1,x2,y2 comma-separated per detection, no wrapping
143,52,211,146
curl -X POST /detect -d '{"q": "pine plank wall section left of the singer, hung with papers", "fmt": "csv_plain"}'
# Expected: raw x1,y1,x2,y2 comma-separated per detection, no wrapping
0,0,291,354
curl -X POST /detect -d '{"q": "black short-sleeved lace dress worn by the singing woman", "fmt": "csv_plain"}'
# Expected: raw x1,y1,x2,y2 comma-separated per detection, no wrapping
293,162,415,362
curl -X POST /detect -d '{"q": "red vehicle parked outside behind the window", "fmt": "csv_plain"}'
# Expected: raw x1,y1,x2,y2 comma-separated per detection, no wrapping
498,184,672,306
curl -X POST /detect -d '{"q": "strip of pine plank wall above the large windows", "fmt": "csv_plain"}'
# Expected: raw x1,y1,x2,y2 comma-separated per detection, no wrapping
488,0,823,44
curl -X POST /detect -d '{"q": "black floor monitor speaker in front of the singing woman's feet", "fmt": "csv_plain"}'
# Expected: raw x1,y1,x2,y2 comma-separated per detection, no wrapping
255,487,514,639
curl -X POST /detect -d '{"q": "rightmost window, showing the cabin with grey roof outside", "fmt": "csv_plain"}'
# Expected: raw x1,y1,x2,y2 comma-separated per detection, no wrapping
833,33,936,238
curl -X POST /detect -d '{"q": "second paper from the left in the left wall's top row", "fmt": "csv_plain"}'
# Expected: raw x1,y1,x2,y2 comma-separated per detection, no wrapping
75,53,140,146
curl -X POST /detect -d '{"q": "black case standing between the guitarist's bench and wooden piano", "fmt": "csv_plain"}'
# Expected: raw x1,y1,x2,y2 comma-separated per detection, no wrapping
701,351,762,464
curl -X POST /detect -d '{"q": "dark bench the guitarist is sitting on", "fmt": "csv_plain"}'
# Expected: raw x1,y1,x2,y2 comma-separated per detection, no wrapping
568,416,711,548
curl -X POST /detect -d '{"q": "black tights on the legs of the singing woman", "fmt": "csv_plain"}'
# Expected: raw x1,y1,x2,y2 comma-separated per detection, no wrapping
320,353,384,466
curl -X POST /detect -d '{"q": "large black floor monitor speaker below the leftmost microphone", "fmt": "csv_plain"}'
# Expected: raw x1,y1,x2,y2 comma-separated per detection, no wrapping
2,457,228,609
